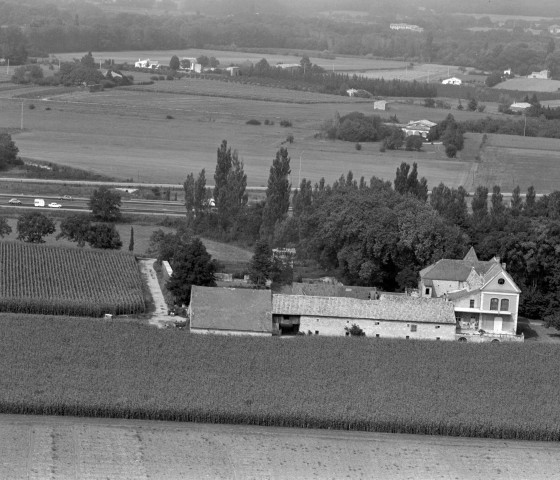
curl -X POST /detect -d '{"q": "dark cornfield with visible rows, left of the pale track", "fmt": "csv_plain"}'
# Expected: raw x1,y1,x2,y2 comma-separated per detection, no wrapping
0,242,144,317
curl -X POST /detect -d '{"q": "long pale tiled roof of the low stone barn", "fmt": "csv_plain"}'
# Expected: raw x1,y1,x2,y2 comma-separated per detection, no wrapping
272,294,455,323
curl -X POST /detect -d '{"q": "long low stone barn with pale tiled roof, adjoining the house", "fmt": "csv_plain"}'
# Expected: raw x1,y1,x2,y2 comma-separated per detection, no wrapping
272,294,455,340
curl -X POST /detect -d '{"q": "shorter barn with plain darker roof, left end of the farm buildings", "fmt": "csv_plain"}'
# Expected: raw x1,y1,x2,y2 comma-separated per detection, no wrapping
189,285,272,336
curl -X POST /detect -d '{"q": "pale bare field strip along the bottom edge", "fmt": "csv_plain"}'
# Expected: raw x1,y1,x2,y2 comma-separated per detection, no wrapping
0,415,560,480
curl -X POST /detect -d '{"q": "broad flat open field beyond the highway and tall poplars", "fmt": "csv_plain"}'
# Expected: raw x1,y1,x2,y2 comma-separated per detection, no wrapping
0,84,476,186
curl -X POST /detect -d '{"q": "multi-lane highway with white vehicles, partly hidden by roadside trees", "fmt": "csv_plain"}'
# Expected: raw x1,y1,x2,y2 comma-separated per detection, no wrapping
0,194,185,217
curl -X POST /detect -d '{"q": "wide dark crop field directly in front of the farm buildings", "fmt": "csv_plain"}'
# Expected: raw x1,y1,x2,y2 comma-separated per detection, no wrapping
0,315,560,441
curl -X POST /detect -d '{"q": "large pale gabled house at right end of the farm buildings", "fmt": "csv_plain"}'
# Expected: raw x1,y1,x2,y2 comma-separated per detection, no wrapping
419,247,523,342
